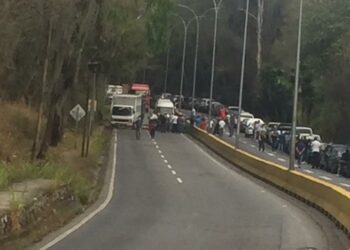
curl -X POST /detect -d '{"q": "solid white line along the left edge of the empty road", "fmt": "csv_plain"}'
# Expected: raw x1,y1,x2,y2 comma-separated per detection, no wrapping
39,130,117,250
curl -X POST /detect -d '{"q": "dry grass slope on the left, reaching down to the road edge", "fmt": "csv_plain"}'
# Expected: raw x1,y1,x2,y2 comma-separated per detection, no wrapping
0,102,108,250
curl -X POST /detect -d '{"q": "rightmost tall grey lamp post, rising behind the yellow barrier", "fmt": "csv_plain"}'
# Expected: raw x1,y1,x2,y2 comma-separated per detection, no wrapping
289,0,303,170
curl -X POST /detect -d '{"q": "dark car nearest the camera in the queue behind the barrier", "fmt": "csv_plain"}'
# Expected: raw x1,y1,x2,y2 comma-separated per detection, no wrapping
320,143,349,173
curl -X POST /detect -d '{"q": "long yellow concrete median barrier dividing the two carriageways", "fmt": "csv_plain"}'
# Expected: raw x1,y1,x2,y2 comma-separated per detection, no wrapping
187,126,350,233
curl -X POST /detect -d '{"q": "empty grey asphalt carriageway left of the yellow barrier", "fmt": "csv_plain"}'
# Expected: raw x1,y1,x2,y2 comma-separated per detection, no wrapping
47,130,349,250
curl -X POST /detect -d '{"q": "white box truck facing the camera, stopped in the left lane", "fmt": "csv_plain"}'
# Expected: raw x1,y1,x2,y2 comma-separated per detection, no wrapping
111,94,142,126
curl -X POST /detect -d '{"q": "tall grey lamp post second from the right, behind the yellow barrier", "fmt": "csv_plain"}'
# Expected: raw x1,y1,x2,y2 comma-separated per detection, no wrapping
236,0,249,148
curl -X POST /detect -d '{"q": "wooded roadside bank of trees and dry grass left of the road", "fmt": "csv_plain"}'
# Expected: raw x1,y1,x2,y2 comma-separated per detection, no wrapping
0,0,172,246
